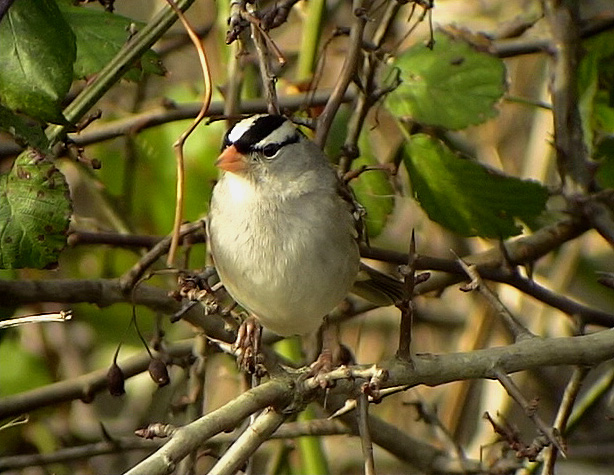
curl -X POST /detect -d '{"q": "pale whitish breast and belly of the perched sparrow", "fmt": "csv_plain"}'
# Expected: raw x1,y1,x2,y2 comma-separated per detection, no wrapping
209,173,359,336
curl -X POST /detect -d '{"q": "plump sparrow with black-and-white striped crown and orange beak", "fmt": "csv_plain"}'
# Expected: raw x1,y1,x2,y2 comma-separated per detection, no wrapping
208,114,402,336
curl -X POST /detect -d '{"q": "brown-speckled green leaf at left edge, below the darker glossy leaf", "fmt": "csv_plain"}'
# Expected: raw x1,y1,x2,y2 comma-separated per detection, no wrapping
0,149,71,269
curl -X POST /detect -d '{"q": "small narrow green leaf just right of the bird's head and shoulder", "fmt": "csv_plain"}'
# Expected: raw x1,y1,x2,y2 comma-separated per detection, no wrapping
351,131,394,237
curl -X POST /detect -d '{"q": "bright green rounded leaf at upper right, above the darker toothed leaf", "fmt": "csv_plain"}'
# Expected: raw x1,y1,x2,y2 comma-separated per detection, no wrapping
386,32,505,130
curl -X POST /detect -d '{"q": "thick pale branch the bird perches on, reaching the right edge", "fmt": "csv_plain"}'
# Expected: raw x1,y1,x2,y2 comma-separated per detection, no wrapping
120,330,614,475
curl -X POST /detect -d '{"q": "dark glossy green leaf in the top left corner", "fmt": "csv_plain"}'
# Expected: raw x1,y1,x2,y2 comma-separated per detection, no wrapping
0,0,76,123
